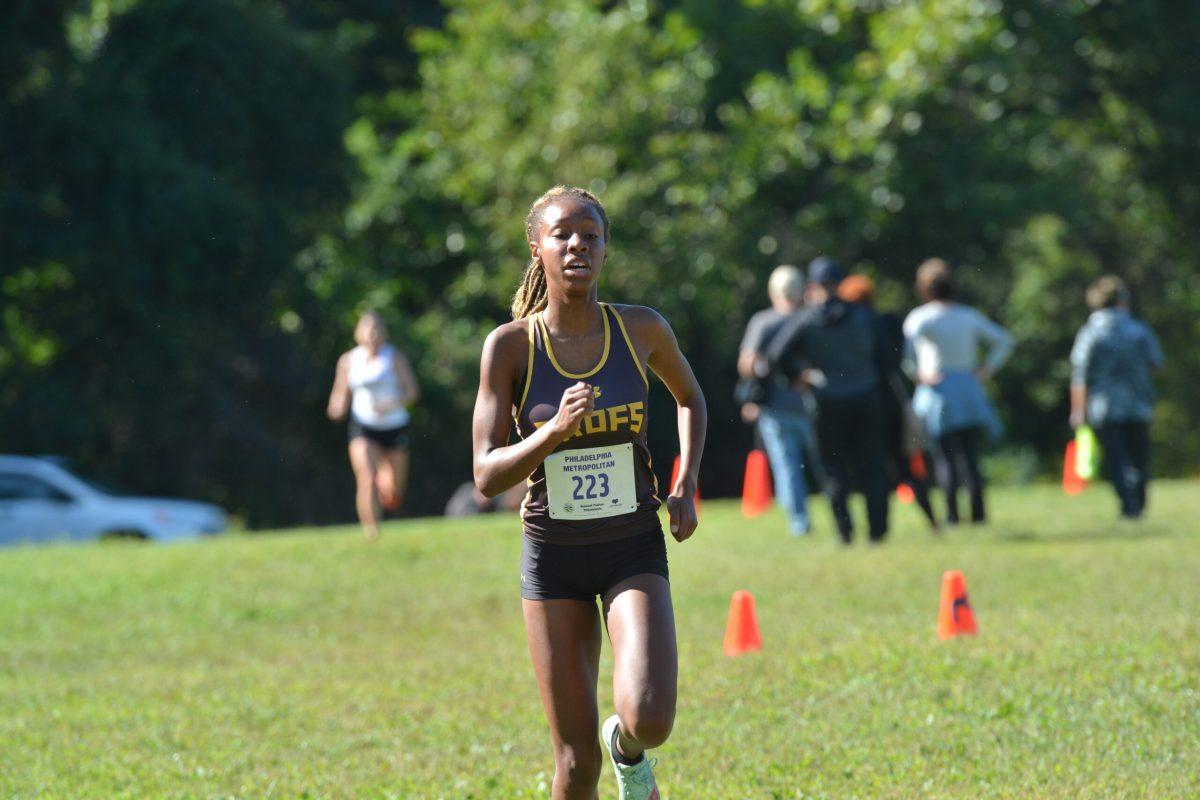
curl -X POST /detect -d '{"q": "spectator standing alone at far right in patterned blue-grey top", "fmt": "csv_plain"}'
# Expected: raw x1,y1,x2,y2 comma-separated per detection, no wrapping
1070,276,1163,519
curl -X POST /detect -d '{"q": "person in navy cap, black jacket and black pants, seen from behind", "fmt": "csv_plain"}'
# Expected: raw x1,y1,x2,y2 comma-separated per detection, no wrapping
767,257,888,545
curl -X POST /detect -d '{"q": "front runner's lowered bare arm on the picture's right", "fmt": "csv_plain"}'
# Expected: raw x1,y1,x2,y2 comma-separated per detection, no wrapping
620,306,708,542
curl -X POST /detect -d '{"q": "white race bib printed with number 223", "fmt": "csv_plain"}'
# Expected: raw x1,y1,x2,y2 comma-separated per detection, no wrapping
545,444,637,519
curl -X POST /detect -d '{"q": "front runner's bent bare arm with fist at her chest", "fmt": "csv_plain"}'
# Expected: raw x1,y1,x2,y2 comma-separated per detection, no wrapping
470,320,594,498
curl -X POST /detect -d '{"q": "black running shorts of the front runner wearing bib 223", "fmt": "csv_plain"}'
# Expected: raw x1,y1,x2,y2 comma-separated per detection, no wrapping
521,528,671,602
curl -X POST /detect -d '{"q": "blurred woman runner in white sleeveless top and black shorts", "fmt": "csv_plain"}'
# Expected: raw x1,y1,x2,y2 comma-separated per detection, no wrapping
329,312,421,540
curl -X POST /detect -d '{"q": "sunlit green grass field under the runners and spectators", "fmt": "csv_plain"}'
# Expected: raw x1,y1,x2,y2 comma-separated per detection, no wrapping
0,482,1200,800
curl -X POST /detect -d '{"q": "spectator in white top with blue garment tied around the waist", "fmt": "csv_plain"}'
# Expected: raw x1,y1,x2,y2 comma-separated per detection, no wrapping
904,258,1013,525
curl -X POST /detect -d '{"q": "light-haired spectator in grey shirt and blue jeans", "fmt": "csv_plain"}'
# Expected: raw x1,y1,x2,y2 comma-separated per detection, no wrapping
737,264,812,536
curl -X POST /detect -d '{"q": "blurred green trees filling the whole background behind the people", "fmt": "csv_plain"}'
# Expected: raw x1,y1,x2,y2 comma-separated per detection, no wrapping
0,0,1200,525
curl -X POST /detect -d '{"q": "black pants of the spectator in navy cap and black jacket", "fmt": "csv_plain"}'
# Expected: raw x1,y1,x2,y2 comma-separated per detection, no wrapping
817,391,888,542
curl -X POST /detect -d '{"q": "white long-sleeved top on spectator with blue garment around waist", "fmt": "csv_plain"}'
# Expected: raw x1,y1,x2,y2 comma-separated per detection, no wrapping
904,301,1013,374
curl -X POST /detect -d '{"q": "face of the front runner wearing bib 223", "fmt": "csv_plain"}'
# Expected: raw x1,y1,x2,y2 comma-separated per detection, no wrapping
529,198,607,294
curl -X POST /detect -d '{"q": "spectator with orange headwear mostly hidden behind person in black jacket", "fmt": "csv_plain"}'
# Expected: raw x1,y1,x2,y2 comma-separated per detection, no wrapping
838,275,937,533
